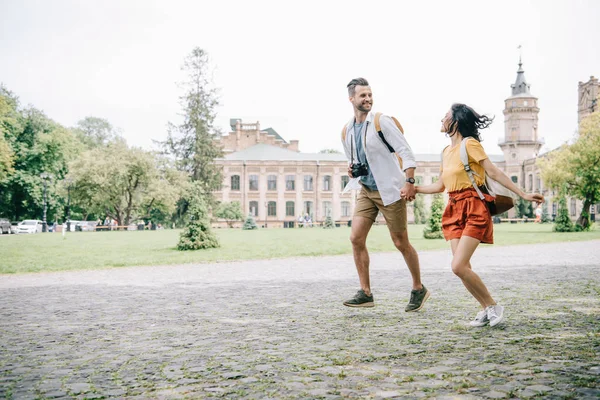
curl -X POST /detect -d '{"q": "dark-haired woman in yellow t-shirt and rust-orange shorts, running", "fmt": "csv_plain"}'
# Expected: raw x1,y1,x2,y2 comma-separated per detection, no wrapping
416,104,544,326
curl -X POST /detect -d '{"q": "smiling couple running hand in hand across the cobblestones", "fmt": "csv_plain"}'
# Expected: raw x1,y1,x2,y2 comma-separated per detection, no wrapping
342,78,544,327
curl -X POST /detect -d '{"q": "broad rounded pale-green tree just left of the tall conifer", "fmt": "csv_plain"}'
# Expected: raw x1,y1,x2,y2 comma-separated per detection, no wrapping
69,140,187,225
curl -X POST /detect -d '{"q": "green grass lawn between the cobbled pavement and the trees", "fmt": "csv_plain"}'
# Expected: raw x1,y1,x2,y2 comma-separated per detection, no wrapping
0,223,600,274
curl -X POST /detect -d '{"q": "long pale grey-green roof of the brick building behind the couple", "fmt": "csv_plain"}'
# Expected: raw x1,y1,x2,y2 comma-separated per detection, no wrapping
222,143,504,162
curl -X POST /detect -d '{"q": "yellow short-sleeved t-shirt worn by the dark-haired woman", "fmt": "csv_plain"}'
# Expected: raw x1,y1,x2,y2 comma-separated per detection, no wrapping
440,139,488,192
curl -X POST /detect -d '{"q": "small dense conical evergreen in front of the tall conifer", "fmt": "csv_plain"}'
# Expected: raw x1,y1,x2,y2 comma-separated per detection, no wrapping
177,183,220,250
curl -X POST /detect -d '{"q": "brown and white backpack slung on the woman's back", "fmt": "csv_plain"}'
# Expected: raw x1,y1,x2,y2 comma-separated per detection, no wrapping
460,137,515,215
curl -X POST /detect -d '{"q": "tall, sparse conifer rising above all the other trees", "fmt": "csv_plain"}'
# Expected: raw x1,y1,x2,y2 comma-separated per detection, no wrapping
162,47,223,196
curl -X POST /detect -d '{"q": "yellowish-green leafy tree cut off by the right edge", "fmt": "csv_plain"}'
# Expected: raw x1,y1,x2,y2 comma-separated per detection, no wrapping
539,112,600,230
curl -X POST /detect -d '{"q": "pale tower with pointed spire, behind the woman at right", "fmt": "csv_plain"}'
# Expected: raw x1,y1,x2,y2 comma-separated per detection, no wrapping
499,57,544,169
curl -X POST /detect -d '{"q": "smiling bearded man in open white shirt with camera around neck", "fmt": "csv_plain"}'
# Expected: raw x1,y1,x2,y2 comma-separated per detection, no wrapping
342,78,429,312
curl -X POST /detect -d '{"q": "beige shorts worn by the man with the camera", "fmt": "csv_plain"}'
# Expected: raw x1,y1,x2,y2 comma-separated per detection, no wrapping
354,187,406,232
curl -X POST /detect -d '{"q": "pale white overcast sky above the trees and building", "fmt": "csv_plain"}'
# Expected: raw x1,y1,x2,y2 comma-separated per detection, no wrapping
0,0,600,154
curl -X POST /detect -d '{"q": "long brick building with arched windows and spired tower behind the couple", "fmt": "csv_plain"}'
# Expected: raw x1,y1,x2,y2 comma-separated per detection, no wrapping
214,61,600,228
